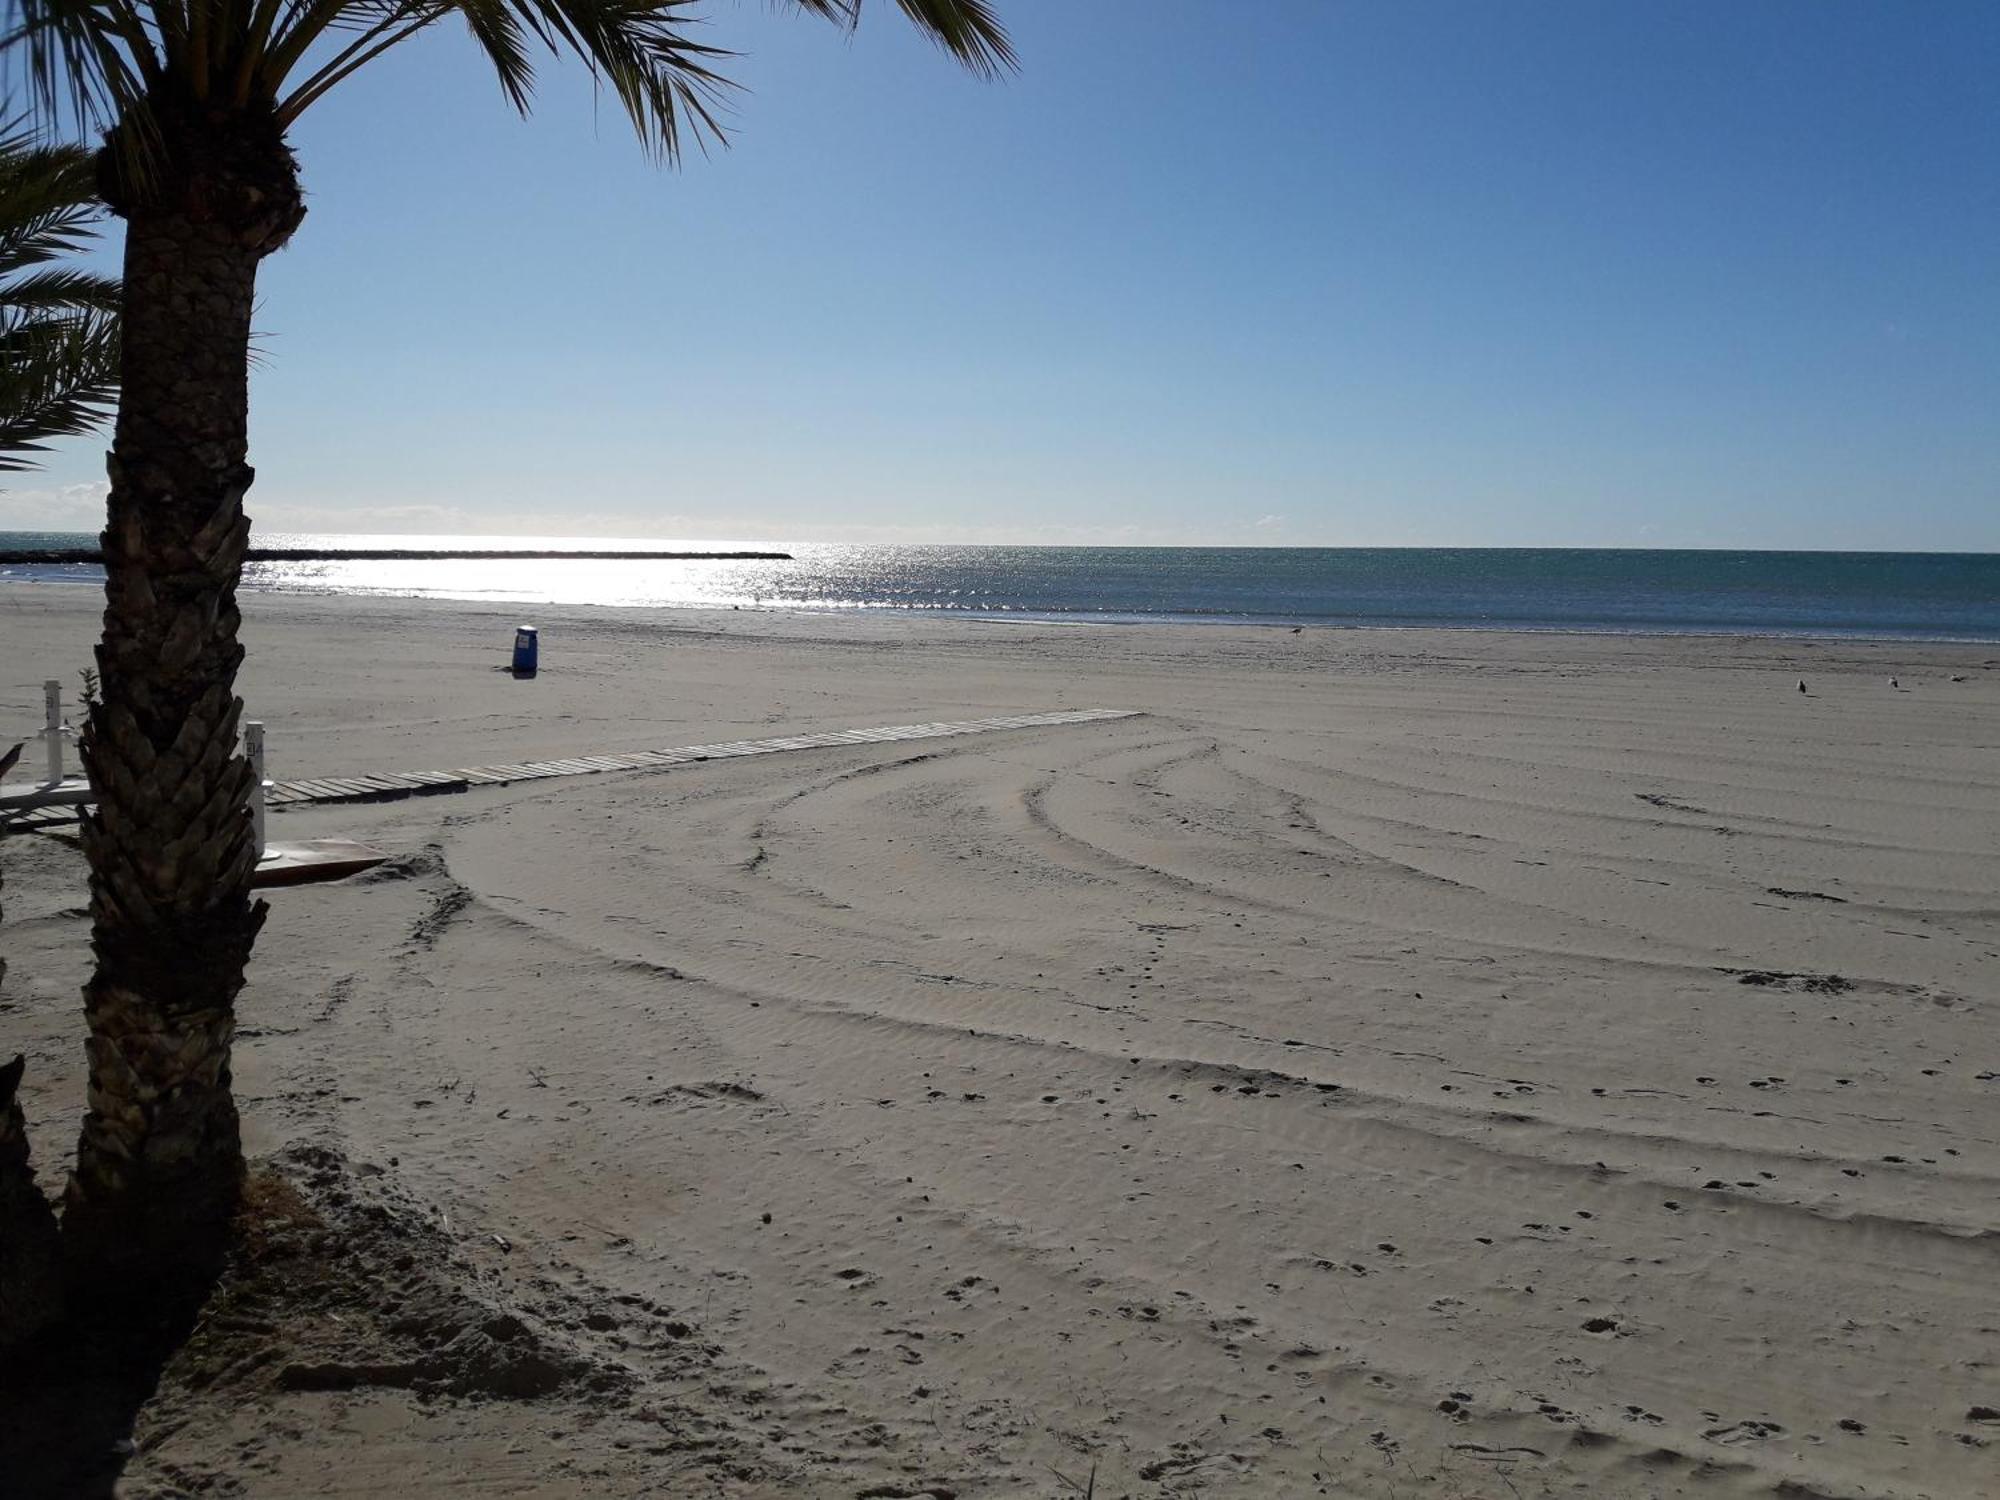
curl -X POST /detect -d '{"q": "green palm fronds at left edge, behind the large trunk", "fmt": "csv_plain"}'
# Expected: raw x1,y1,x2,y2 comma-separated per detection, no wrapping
0,124,118,470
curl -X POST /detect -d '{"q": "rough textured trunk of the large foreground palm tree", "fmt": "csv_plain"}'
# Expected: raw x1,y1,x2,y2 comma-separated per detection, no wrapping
64,108,304,1292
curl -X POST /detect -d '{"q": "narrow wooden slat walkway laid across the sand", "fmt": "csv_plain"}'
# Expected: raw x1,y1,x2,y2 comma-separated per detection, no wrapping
0,708,1138,834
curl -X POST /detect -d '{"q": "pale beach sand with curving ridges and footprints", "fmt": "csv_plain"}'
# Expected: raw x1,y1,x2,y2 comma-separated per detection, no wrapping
0,588,2000,1498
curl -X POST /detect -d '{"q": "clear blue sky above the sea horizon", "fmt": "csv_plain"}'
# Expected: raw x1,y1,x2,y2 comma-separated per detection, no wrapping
0,0,2000,550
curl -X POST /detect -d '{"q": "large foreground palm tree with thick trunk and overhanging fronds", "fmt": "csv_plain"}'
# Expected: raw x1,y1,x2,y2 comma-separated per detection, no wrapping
4,0,1014,1286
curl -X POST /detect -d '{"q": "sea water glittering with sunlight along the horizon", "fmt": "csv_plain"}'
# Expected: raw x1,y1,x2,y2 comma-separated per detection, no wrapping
0,532,2000,640
